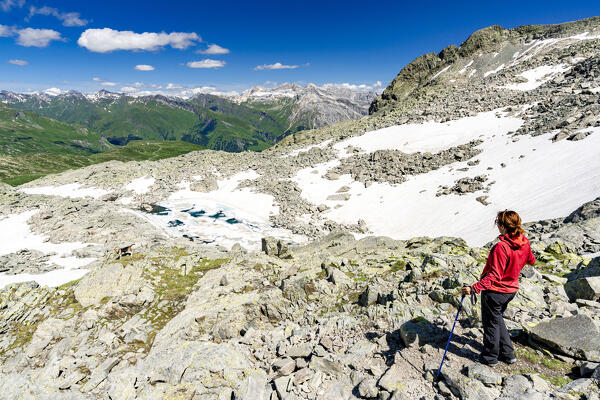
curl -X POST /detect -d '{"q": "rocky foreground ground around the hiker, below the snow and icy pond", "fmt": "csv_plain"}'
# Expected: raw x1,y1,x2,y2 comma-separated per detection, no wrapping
0,189,600,399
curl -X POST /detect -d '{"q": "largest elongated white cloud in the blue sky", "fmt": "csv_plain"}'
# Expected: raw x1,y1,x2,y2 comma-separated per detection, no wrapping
77,28,202,53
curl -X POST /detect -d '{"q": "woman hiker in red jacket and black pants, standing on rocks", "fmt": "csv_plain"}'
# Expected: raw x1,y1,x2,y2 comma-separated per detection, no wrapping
462,210,535,367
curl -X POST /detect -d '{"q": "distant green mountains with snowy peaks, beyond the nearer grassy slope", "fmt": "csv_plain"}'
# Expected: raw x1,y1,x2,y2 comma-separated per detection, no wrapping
0,84,376,152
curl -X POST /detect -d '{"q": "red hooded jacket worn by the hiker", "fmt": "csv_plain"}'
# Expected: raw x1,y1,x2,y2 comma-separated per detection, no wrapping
471,235,535,293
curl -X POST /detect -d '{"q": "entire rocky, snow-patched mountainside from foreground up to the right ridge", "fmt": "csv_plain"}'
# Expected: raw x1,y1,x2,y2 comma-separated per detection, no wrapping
0,18,600,400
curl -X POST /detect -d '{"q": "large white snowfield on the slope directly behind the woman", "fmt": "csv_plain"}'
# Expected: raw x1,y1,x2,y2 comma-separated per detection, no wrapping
293,112,600,246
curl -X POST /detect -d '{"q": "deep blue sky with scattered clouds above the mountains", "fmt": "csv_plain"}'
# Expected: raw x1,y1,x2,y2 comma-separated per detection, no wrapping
0,0,600,94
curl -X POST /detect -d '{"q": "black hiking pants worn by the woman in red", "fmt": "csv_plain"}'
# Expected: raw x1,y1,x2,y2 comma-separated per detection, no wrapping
481,290,516,363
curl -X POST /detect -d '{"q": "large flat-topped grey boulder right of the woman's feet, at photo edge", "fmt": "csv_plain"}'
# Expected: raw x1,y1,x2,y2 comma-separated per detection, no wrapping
525,314,600,362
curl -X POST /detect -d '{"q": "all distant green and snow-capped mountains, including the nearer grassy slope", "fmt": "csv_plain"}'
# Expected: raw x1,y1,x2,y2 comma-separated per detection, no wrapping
0,84,376,184
